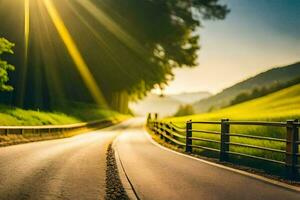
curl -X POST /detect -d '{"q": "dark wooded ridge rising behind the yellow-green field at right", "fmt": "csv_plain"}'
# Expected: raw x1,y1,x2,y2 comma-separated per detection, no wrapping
194,62,300,113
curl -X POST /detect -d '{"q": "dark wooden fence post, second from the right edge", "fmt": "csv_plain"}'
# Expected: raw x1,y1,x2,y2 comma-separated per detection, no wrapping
220,119,230,162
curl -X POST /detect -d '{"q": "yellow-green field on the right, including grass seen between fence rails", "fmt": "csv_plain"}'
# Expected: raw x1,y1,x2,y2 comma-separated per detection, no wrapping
163,84,300,175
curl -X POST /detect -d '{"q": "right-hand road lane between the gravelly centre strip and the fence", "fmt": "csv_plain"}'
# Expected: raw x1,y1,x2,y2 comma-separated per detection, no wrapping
115,121,300,200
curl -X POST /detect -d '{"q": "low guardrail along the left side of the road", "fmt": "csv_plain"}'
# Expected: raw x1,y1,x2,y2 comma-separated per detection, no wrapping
0,120,113,136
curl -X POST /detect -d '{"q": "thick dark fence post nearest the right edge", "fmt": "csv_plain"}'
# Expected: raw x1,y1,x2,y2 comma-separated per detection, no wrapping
285,120,299,180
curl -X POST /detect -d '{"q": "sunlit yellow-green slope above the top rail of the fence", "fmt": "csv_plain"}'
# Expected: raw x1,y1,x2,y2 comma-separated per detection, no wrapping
168,84,300,122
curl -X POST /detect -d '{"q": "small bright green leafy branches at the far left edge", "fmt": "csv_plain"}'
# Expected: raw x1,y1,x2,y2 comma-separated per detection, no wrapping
0,38,15,91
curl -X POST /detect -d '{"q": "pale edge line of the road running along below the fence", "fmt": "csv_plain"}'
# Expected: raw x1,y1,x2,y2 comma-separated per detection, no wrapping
143,127,300,192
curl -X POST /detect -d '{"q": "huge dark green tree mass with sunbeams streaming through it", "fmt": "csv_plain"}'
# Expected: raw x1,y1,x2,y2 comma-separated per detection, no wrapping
0,0,229,111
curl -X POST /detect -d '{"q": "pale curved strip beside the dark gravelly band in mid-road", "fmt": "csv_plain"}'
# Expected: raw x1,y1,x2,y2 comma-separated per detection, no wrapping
112,137,140,200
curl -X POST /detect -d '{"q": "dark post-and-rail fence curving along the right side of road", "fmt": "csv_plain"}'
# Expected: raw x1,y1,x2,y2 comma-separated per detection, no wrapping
147,117,300,180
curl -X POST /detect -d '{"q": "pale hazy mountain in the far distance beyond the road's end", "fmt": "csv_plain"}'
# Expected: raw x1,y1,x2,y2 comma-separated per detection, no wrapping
130,92,211,116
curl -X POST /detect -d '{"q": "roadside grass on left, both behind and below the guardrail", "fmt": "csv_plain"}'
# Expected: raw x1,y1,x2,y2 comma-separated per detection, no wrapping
0,102,130,146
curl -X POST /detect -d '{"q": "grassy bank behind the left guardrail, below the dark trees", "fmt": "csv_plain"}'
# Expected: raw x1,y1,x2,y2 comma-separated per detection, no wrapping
0,103,124,126
